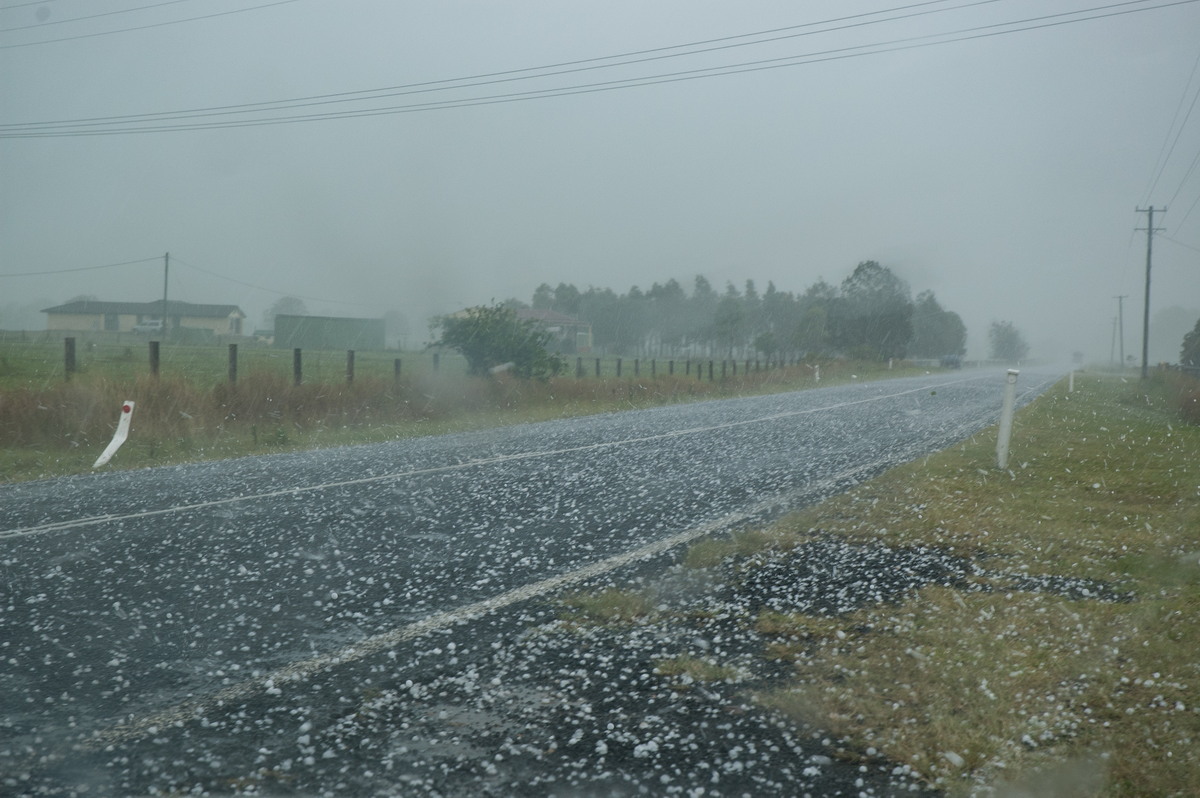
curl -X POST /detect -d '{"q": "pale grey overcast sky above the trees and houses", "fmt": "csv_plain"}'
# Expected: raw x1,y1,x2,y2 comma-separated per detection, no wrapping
0,0,1200,360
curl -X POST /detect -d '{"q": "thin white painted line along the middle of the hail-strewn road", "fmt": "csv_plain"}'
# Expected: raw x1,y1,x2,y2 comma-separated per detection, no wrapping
0,374,994,540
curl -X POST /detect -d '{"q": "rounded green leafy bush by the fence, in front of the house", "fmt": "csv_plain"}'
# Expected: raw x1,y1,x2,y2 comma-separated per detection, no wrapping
436,305,566,379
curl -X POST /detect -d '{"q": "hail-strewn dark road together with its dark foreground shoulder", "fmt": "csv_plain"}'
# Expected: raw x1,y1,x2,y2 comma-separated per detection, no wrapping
0,371,1055,796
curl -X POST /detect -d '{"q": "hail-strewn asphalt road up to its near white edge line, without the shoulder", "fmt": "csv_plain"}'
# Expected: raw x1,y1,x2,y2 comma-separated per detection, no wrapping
0,370,1055,794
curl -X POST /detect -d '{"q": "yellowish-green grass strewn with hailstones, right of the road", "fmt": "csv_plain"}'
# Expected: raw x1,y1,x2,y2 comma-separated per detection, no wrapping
729,377,1200,796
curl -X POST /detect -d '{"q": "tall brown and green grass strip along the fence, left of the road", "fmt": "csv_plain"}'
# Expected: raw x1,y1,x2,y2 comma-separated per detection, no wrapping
0,353,919,482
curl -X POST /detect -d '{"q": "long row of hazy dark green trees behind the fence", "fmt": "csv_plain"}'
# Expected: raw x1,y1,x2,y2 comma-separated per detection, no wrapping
506,260,967,360
